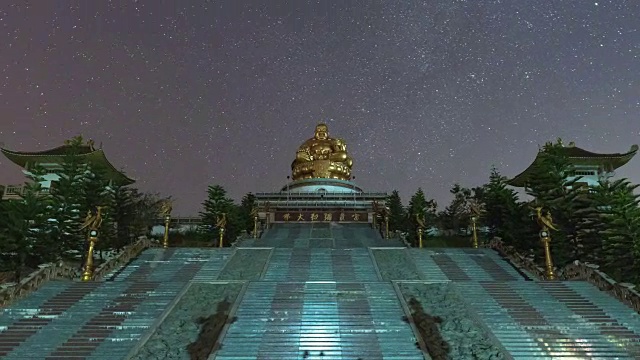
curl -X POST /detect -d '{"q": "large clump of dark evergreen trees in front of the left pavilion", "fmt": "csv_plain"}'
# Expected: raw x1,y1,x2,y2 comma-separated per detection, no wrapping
0,136,168,280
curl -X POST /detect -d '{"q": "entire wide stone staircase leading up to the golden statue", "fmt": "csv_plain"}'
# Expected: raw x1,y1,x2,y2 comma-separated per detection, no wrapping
0,224,640,360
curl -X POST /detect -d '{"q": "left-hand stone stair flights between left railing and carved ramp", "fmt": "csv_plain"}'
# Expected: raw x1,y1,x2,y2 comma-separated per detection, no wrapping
0,248,222,360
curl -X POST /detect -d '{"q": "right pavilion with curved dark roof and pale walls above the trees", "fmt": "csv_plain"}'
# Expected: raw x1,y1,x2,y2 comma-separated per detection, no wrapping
507,142,638,187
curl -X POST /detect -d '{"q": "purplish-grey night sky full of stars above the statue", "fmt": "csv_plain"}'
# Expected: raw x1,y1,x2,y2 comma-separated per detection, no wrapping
0,0,640,215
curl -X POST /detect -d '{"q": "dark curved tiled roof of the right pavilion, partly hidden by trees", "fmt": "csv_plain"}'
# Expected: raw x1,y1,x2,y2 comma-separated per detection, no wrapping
507,145,638,187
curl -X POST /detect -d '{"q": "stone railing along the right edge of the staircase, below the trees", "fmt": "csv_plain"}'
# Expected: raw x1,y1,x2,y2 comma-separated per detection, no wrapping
486,238,640,313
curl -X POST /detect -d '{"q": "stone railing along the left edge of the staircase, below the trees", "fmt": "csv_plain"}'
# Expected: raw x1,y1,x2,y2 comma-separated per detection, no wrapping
0,237,153,307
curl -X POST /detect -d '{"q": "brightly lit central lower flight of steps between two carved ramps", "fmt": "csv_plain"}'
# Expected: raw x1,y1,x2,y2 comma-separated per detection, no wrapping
216,282,424,360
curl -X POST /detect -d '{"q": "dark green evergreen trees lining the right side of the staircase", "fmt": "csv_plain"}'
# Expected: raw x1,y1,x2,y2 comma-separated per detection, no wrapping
387,139,640,284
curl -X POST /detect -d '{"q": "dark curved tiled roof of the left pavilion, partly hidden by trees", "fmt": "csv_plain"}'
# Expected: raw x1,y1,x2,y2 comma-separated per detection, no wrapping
0,145,135,185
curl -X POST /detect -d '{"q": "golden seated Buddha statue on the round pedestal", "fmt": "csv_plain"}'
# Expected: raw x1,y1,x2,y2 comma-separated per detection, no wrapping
291,123,353,180
